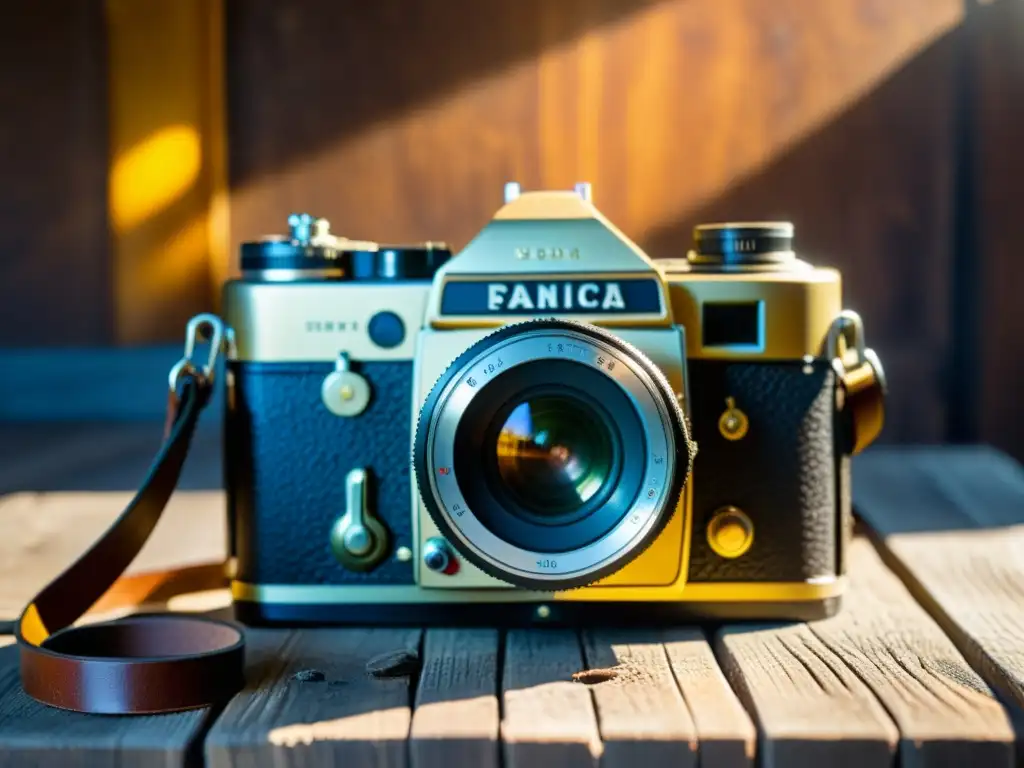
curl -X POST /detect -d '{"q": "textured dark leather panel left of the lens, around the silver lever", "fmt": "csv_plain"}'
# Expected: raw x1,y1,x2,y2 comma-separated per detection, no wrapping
225,361,415,585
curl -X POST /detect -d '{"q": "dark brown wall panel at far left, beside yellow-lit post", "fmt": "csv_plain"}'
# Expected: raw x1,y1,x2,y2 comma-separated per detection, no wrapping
0,0,113,347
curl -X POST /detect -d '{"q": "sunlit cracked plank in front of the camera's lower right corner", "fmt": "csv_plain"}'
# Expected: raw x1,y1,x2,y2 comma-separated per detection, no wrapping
717,624,899,768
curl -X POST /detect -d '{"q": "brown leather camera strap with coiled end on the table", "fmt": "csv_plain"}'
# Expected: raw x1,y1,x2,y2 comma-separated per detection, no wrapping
15,376,245,715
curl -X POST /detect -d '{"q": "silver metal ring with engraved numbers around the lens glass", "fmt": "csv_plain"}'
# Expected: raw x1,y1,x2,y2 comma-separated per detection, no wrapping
426,329,677,582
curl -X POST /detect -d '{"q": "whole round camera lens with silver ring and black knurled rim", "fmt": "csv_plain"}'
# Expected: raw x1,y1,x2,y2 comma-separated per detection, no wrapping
414,319,693,590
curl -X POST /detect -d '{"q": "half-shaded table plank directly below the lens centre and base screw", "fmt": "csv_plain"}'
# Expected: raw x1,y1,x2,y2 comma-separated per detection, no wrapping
501,630,601,768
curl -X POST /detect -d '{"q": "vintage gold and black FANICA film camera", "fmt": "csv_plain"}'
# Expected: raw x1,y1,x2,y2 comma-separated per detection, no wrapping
224,183,884,625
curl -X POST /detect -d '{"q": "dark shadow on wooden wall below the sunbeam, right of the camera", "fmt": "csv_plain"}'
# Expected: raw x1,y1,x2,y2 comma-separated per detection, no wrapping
641,16,970,450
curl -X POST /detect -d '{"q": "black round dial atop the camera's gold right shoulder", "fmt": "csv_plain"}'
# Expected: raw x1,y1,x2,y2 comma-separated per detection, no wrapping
689,221,795,267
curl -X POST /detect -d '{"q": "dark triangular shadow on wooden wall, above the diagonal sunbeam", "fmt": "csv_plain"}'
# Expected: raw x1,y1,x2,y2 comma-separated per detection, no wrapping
225,0,663,187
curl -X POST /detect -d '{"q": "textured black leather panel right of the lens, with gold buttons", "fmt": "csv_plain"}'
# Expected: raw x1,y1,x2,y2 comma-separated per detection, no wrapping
689,360,846,582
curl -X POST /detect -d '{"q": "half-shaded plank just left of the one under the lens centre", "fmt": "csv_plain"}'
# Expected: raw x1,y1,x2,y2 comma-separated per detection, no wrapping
410,630,500,768
